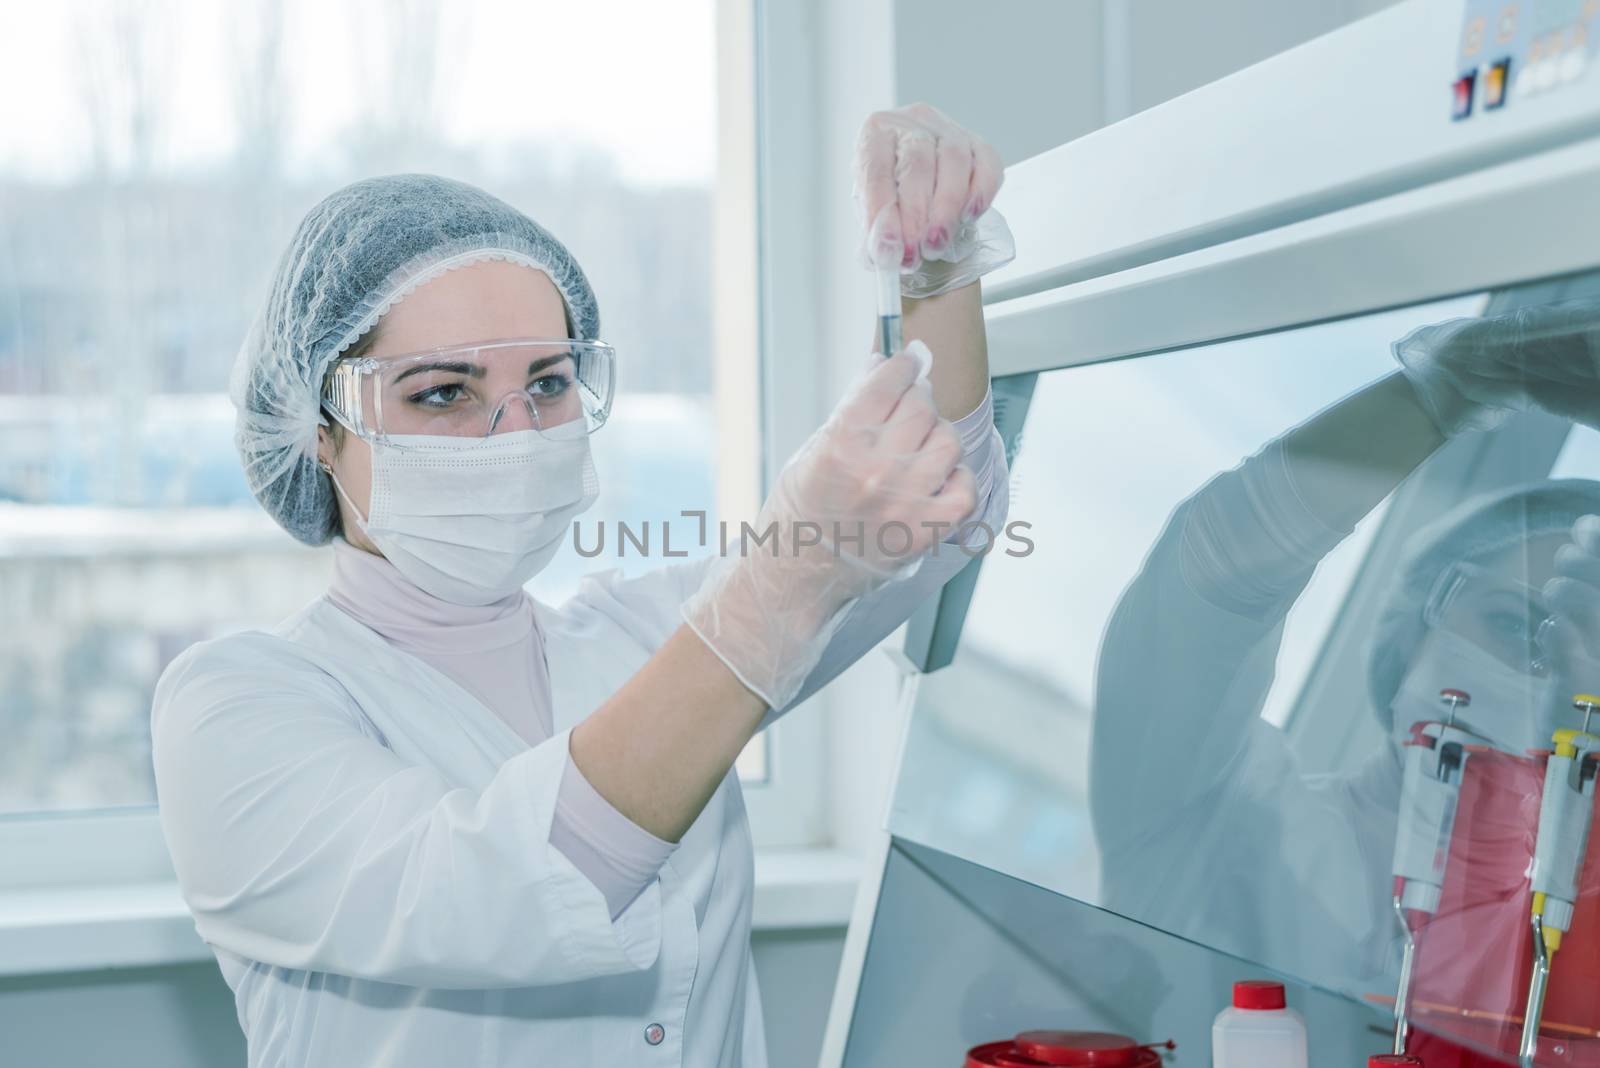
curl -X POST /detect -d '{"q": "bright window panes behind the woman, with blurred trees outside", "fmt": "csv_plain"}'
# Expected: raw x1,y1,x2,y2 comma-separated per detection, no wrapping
0,0,780,814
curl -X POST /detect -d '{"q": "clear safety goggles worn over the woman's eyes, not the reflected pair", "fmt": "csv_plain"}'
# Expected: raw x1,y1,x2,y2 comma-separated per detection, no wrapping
322,337,616,448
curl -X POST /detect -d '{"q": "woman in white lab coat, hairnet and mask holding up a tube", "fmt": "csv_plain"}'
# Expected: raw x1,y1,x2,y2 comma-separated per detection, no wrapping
152,106,1010,1068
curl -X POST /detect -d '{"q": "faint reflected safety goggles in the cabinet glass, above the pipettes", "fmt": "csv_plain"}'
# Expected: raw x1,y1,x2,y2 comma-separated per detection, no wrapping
1422,563,1557,678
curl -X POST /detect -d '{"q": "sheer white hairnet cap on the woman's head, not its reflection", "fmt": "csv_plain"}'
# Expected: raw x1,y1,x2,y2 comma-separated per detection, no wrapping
229,174,600,545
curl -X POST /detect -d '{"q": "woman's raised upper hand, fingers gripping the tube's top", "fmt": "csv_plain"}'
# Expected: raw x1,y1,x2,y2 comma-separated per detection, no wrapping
854,104,1005,269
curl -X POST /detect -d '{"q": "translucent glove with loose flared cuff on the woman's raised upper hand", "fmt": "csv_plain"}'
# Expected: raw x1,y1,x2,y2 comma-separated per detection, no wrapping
854,104,1016,297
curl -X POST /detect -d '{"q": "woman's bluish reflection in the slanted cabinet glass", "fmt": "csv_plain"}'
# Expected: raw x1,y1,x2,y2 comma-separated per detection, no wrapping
1091,287,1600,1004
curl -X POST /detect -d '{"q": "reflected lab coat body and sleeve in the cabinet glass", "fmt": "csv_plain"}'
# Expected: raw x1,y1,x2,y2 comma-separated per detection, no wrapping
1090,492,1402,996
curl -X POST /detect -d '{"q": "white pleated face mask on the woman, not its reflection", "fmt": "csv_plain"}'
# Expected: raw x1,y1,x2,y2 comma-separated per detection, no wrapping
333,420,600,604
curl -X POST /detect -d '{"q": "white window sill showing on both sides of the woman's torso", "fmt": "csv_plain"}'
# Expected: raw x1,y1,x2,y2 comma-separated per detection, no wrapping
0,849,861,977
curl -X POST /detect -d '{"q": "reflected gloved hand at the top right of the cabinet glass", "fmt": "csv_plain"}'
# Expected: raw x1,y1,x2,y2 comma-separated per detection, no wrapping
1394,301,1600,435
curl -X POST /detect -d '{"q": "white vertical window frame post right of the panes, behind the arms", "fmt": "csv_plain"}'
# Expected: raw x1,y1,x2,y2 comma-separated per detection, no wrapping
712,0,830,849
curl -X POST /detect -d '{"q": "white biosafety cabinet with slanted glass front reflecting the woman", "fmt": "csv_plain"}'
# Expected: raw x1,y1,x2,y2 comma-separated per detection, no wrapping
824,0,1600,1068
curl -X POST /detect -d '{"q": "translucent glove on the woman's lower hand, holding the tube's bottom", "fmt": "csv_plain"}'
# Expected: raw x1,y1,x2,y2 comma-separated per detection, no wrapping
683,341,978,708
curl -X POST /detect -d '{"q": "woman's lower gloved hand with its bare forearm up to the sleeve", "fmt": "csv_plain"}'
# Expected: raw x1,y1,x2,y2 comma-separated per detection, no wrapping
571,342,976,841
